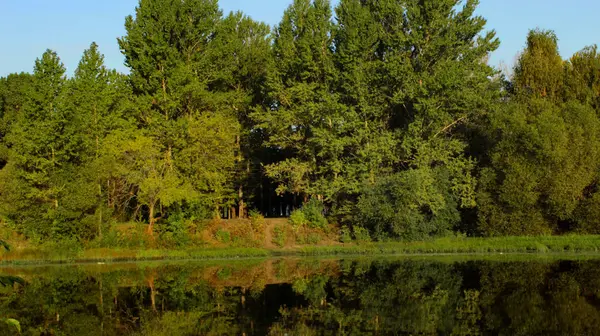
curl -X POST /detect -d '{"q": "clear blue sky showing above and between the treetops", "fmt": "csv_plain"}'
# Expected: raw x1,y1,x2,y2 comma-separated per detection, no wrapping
0,0,600,76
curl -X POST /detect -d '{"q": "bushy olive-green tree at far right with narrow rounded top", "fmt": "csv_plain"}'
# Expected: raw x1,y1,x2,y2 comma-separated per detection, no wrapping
479,30,600,236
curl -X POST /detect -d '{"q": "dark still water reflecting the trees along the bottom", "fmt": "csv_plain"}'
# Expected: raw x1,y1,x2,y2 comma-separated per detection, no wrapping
0,259,600,335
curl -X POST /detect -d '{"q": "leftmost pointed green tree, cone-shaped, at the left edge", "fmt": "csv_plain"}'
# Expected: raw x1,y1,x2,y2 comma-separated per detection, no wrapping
1,50,74,237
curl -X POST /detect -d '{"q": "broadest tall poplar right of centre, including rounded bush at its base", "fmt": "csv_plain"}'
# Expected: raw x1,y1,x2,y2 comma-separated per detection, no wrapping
336,0,499,239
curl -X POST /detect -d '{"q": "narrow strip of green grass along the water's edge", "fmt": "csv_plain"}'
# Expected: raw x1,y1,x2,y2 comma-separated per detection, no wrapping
0,235,600,265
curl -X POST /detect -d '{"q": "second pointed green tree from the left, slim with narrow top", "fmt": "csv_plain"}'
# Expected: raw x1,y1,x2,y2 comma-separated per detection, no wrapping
65,43,132,236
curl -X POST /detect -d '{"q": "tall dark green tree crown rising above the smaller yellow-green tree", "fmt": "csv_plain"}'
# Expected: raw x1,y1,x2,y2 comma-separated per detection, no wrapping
119,0,222,122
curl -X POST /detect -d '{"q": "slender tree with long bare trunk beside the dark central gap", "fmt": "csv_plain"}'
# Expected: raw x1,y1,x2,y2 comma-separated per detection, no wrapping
209,12,272,217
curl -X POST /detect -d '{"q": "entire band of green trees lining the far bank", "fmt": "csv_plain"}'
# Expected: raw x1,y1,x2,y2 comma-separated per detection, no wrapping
0,0,600,241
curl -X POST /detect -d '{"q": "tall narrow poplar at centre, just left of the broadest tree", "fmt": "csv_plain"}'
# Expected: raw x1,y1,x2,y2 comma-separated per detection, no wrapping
254,0,342,199
